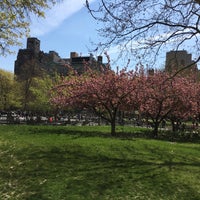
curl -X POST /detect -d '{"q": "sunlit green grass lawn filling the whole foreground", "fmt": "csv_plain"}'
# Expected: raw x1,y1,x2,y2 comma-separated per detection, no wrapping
0,125,200,200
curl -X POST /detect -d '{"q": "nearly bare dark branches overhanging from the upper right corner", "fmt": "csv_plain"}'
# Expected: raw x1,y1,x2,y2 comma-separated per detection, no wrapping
86,0,200,66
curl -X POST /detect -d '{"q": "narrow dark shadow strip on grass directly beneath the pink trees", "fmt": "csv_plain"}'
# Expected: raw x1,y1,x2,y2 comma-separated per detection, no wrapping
18,126,200,143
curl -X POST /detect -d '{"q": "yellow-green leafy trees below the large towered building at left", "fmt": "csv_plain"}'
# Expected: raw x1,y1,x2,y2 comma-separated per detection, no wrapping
0,69,55,113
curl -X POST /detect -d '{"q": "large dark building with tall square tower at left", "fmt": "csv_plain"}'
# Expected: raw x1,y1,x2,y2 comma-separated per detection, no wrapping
14,37,105,78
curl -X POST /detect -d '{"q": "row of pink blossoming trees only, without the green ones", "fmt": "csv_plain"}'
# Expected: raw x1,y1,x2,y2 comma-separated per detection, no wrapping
50,63,200,137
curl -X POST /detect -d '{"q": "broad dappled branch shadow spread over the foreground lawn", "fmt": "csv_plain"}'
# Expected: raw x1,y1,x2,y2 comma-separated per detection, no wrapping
0,143,200,200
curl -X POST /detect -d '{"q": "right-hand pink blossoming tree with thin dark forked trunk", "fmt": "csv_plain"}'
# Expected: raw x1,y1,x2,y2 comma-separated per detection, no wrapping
139,71,193,137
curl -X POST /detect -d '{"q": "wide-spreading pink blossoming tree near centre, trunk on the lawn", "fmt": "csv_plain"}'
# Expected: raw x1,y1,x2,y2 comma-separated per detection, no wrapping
51,69,137,135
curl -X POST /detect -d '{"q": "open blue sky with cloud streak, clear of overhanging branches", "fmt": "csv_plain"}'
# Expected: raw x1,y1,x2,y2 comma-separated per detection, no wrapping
0,0,100,72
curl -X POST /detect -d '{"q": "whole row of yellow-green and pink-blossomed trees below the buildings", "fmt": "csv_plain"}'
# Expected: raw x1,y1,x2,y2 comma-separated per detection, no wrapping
0,59,200,137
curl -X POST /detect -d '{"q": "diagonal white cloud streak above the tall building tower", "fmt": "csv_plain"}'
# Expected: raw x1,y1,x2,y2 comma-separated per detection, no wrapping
30,0,95,36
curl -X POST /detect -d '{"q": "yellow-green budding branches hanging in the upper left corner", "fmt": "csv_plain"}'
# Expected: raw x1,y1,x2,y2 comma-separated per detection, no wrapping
0,0,56,55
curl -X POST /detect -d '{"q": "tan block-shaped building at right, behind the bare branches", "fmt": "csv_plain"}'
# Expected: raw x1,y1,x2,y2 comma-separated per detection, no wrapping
165,50,198,75
